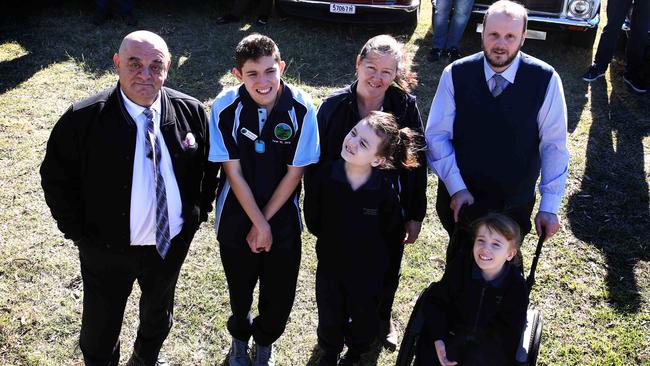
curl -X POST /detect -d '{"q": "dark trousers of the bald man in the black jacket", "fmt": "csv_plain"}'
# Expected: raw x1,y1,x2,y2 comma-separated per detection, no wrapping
79,229,194,366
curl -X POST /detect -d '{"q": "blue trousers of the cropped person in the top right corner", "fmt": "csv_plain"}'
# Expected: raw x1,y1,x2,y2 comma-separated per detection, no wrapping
594,0,650,77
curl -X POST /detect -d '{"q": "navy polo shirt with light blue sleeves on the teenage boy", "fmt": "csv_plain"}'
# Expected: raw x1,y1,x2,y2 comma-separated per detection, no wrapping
208,82,320,248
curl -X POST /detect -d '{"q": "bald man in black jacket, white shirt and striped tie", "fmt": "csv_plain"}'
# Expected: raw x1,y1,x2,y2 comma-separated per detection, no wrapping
41,31,218,366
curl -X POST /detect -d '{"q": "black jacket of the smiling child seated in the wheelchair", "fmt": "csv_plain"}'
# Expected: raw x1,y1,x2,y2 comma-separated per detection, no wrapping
426,252,528,365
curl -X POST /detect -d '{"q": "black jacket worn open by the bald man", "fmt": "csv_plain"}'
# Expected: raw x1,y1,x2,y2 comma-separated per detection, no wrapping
41,83,218,249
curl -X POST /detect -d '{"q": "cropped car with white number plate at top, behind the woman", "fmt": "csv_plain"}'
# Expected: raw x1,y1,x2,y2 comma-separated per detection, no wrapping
276,0,421,26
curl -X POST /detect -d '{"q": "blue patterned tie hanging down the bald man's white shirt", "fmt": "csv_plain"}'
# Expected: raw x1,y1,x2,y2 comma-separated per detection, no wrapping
143,108,170,259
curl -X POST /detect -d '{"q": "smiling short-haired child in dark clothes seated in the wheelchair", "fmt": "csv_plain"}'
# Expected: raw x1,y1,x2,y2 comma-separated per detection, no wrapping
416,213,528,366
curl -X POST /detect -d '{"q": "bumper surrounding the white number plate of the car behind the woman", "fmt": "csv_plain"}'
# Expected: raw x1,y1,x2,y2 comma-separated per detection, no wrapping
277,0,420,23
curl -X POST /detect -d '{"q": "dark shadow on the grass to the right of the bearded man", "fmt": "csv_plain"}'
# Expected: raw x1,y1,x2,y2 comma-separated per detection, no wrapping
568,66,650,313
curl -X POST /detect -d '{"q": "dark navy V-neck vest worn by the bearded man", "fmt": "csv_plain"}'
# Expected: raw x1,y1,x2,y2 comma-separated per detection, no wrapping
451,52,553,209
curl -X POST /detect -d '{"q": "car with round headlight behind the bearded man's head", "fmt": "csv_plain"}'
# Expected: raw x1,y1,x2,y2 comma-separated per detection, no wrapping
472,0,600,48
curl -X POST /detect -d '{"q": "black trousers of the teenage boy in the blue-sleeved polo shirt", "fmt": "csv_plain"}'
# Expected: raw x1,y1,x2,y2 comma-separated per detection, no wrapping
219,236,302,346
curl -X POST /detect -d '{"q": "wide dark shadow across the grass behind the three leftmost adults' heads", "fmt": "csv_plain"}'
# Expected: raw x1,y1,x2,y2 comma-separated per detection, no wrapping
0,0,422,101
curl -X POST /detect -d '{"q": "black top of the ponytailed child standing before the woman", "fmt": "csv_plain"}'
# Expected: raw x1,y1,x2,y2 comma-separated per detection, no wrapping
304,159,403,280
